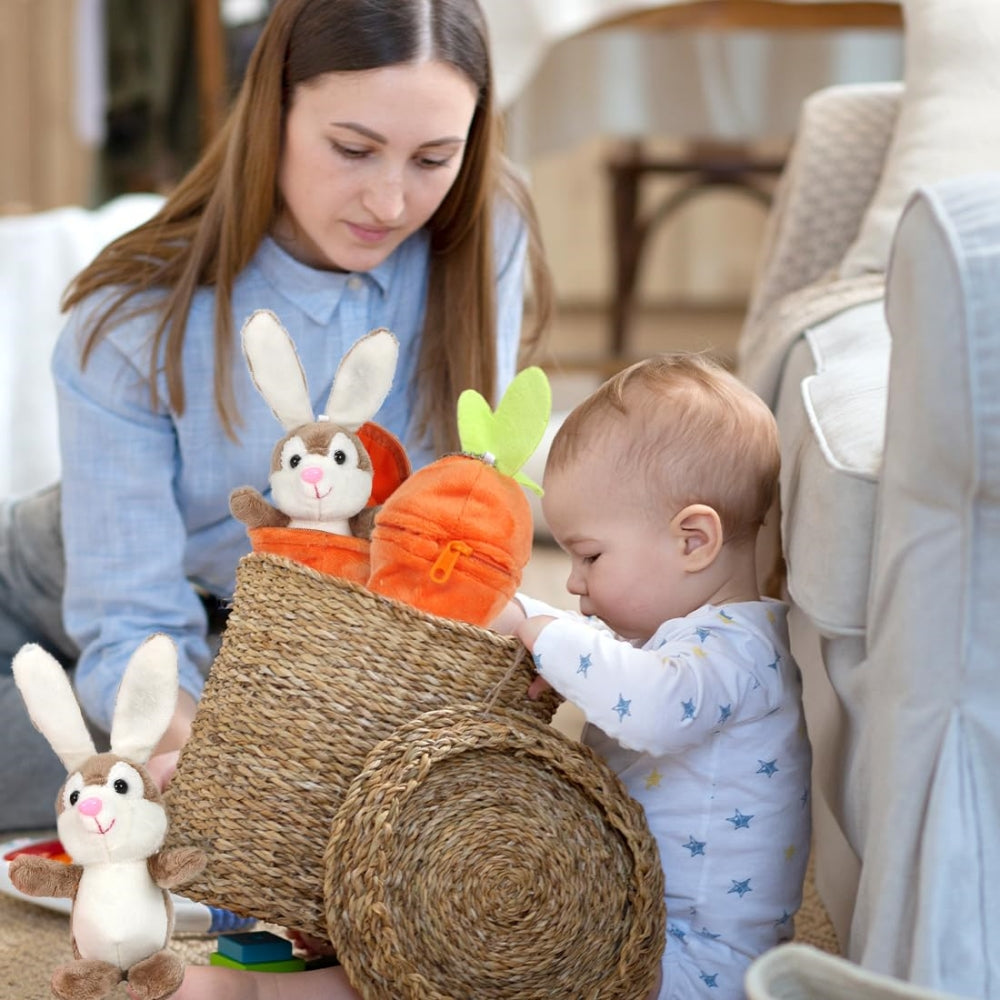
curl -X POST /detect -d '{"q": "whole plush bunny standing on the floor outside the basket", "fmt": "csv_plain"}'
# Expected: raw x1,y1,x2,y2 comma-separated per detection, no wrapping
10,635,206,1000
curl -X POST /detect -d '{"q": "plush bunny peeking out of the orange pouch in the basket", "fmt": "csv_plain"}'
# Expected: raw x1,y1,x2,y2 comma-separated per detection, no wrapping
229,309,399,538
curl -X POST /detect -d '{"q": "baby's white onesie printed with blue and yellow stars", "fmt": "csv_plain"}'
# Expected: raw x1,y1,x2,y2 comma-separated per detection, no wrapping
518,595,811,1000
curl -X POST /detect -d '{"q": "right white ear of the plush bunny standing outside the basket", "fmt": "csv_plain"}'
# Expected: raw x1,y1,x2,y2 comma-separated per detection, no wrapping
111,635,177,764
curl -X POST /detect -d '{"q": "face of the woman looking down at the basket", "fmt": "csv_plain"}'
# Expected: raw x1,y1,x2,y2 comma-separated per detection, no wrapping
274,61,477,271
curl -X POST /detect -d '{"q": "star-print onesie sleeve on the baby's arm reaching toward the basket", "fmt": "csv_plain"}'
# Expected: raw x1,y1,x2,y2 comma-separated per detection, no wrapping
534,618,776,756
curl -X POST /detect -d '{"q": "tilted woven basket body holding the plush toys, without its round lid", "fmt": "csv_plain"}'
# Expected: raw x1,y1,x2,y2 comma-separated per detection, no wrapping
160,553,556,937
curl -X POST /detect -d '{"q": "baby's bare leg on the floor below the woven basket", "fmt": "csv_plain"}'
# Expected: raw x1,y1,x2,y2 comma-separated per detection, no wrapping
174,965,361,1000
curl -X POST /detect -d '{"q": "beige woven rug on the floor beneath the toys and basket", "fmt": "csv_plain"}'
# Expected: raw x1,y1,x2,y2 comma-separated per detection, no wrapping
0,836,838,1000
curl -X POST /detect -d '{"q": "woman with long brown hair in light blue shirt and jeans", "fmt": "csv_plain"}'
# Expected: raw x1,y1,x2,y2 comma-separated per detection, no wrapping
0,0,550,828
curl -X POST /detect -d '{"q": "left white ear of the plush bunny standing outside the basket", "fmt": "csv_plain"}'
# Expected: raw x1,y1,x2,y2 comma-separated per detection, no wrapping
11,643,97,773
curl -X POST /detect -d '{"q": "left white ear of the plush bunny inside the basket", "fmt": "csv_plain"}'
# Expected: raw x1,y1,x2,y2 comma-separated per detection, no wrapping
240,309,314,431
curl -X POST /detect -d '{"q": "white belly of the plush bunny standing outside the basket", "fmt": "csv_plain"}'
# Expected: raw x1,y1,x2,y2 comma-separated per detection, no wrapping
72,861,167,969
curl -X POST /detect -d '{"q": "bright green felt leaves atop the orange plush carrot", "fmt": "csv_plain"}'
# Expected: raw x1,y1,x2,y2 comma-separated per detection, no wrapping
458,367,552,496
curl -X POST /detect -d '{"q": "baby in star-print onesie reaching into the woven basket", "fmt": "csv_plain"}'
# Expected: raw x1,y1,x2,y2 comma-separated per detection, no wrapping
496,355,811,1000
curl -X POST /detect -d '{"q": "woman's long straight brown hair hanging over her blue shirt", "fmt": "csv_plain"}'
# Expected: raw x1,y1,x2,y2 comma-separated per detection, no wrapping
63,0,552,452
